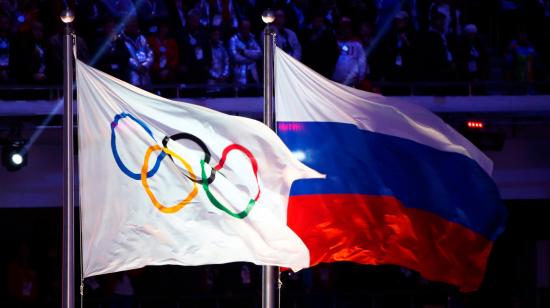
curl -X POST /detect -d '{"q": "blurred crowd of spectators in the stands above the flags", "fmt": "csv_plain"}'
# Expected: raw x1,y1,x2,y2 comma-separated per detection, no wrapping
0,0,550,90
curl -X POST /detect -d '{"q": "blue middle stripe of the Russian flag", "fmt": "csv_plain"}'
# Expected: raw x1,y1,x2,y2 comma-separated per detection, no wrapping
278,122,506,240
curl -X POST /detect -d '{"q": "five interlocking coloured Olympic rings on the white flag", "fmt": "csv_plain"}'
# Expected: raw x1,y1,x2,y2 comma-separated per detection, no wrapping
111,112,260,219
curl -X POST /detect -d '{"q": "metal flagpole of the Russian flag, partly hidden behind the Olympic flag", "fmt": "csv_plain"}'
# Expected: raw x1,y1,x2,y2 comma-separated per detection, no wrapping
262,10,279,308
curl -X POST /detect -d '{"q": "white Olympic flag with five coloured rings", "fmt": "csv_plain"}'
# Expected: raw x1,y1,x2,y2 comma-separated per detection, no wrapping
76,61,322,277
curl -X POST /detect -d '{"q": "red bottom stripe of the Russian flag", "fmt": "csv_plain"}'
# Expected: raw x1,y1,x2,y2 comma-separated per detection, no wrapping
288,194,492,292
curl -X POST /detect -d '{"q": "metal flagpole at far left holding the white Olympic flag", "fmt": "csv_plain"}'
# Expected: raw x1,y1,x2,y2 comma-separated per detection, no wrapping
60,9,74,308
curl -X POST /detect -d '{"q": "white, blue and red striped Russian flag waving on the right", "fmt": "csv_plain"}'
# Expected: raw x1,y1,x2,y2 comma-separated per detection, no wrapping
275,48,507,292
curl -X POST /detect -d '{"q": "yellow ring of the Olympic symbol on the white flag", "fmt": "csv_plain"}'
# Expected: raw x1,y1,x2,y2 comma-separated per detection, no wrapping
141,145,199,214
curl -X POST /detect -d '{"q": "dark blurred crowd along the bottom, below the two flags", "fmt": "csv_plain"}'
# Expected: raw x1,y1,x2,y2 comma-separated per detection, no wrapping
0,242,458,308
